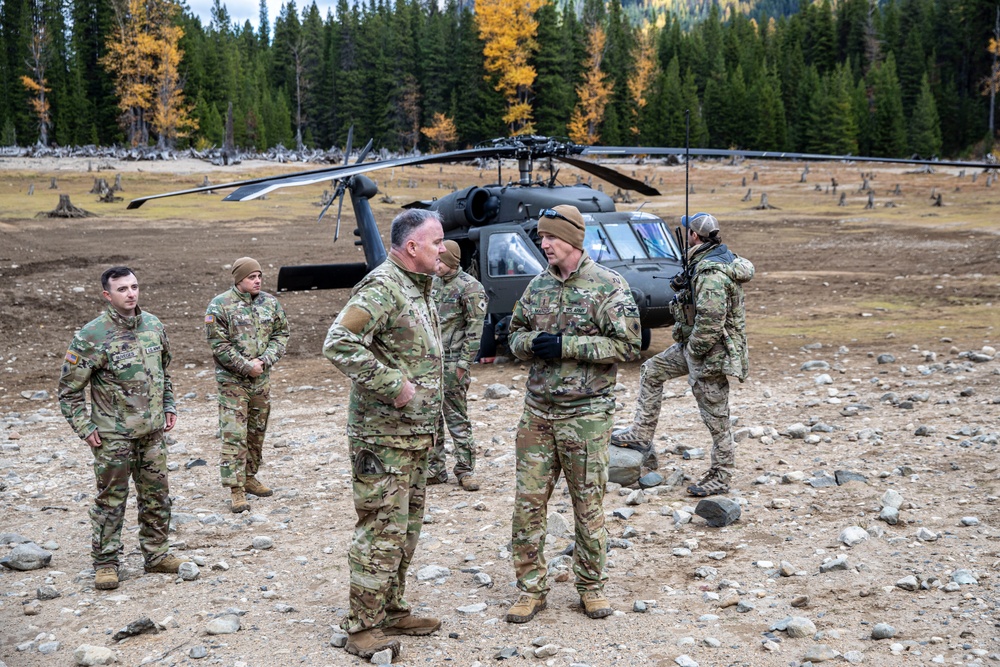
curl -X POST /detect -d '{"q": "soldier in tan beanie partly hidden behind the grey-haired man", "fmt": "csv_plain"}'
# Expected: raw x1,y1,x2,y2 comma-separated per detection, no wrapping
427,241,486,491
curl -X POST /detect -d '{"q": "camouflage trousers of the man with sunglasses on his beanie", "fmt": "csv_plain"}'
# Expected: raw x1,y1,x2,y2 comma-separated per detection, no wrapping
511,410,612,598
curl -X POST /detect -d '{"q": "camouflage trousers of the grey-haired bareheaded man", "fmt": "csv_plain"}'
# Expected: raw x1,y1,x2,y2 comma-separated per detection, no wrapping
341,435,431,633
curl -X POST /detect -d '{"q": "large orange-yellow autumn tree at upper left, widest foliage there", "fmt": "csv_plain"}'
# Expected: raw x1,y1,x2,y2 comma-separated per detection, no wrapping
101,0,196,146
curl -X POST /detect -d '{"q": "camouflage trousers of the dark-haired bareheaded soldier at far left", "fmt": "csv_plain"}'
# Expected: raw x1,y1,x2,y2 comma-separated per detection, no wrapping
90,431,170,568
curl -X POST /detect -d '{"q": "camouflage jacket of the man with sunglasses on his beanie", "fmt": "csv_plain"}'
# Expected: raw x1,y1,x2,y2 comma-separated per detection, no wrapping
509,253,640,419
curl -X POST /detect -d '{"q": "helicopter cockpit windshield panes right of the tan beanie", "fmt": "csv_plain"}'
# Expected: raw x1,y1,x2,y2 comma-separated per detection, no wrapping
584,214,680,262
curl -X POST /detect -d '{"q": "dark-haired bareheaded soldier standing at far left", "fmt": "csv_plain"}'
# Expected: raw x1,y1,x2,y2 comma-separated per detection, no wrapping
59,266,184,589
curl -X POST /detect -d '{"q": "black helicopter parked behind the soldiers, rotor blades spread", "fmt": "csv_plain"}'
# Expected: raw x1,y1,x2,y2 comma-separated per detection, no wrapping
128,134,997,357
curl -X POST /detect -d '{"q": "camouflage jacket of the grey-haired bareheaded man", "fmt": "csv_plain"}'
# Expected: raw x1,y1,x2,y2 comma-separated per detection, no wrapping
323,255,444,449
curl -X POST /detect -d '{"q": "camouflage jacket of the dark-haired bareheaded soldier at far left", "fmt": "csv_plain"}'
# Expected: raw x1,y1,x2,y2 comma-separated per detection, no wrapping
59,306,177,439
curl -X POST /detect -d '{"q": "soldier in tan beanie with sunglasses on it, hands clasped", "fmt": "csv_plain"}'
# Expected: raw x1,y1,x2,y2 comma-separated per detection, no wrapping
506,206,640,623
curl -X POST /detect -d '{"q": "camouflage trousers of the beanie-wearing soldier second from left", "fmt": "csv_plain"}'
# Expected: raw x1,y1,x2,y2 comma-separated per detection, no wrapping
219,382,271,487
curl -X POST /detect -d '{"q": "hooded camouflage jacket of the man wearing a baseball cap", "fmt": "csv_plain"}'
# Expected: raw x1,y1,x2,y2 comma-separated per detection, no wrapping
671,245,754,382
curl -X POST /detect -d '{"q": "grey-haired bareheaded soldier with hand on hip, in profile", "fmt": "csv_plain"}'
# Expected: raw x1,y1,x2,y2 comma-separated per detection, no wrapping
323,209,444,658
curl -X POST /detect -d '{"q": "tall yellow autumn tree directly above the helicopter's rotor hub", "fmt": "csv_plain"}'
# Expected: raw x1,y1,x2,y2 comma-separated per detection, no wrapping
476,0,549,136
